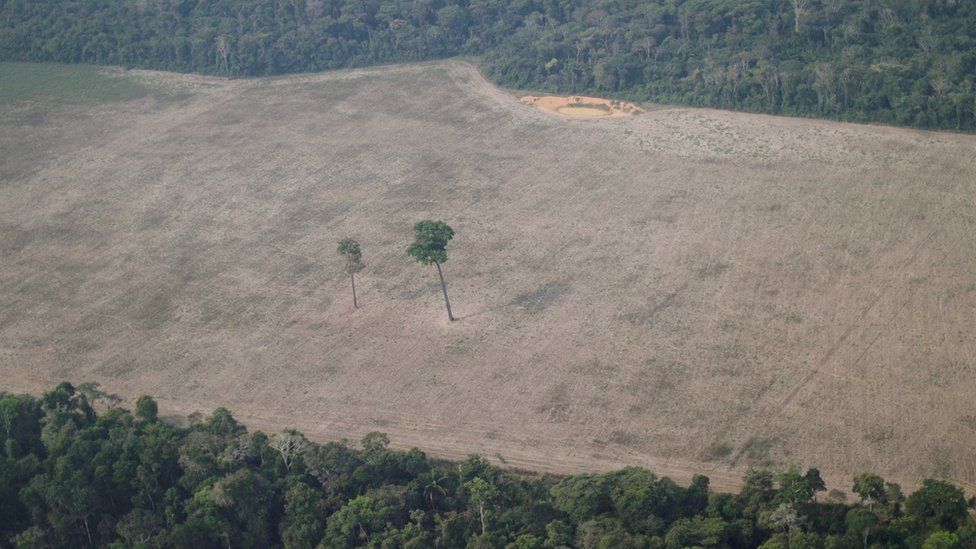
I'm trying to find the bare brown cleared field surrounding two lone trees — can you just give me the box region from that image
[0,61,976,489]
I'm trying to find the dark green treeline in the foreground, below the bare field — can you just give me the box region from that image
[0,383,976,549]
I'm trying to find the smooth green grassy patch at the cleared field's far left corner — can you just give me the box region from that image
[0,62,150,104]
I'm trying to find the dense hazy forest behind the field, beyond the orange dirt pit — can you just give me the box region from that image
[0,0,976,131]
